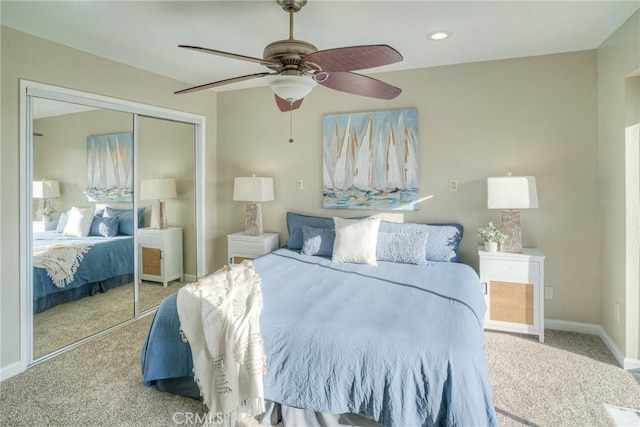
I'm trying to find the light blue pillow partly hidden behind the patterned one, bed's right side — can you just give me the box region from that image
[380,221,463,262]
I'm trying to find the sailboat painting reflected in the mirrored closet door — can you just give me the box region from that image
[86,132,133,203]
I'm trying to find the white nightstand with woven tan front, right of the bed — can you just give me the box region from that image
[478,246,544,342]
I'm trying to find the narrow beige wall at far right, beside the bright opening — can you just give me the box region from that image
[598,12,640,359]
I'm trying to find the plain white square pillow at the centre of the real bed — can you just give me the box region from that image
[331,217,380,265]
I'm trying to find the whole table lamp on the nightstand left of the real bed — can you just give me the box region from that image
[233,176,273,236]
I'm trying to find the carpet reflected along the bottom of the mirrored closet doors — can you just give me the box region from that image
[33,280,187,359]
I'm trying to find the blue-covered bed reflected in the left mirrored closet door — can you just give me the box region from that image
[33,206,135,313]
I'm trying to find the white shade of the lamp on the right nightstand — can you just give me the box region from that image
[487,176,538,209]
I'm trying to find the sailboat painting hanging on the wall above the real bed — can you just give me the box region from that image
[322,108,420,210]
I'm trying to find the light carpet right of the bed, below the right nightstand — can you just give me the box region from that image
[485,330,640,427]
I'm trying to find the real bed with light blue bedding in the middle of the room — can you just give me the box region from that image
[141,217,497,427]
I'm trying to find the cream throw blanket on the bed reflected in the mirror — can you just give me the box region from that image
[33,243,92,288]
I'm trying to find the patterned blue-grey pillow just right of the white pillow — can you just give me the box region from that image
[376,231,429,265]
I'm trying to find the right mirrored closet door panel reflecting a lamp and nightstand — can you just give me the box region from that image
[137,116,196,311]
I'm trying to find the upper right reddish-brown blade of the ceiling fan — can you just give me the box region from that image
[304,44,403,72]
